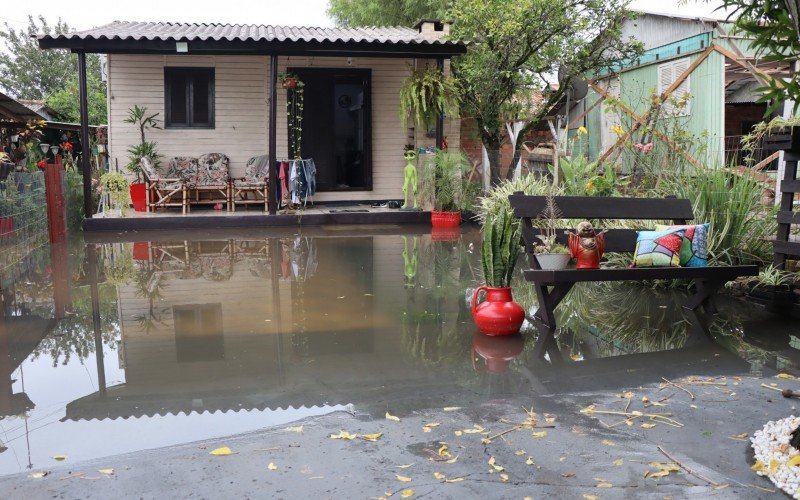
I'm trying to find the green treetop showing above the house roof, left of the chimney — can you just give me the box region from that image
[328,0,448,26]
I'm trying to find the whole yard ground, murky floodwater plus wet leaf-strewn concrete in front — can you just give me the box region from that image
[0,226,800,498]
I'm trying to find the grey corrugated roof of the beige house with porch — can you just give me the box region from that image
[39,21,462,45]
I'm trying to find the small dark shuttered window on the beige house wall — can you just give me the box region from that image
[164,68,214,128]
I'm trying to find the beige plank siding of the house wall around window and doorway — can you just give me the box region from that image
[108,54,461,201]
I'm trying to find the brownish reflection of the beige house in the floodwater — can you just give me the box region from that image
[65,233,470,420]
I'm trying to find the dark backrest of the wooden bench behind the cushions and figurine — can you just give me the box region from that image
[508,193,694,267]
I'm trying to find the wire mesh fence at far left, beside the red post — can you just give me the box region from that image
[0,172,48,280]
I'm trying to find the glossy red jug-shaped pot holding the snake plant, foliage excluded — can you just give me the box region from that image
[472,286,525,335]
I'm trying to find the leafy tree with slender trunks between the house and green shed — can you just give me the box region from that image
[450,0,640,184]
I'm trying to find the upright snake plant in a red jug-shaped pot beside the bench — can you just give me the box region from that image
[472,205,525,335]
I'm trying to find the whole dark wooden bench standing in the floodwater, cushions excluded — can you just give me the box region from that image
[509,193,758,341]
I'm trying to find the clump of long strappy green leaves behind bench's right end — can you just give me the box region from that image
[661,167,777,265]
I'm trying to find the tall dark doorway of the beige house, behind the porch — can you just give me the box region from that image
[289,68,372,191]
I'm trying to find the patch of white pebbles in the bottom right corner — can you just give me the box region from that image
[750,415,800,499]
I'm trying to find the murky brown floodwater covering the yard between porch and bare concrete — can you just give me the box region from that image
[0,226,800,474]
